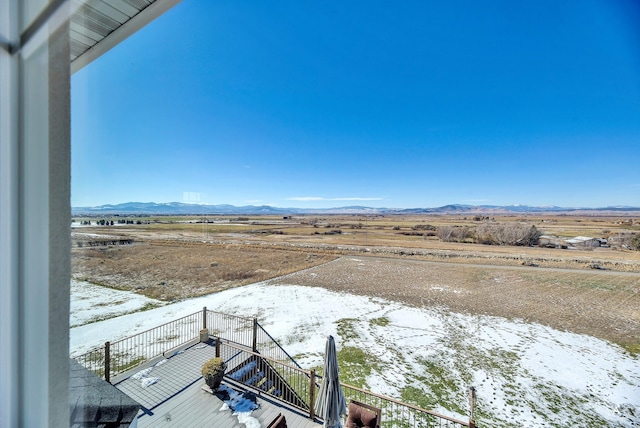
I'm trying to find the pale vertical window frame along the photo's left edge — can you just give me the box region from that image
[0,0,70,427]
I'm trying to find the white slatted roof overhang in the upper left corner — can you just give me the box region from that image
[69,0,181,73]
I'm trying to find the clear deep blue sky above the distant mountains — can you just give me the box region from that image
[71,0,640,208]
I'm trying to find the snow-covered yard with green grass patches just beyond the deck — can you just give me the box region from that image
[71,282,640,427]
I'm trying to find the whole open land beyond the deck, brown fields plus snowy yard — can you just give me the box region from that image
[72,216,640,427]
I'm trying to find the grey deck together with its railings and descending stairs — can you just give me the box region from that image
[73,307,475,428]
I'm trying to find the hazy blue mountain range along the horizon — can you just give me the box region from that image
[71,202,640,216]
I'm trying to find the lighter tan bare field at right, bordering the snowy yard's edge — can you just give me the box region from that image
[271,256,640,352]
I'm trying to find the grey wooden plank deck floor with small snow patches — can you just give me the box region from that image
[114,343,321,428]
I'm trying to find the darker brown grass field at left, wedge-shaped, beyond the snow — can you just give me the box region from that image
[72,241,333,300]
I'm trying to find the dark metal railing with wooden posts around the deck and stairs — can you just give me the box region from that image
[74,307,474,428]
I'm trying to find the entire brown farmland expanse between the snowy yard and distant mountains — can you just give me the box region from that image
[72,216,640,352]
